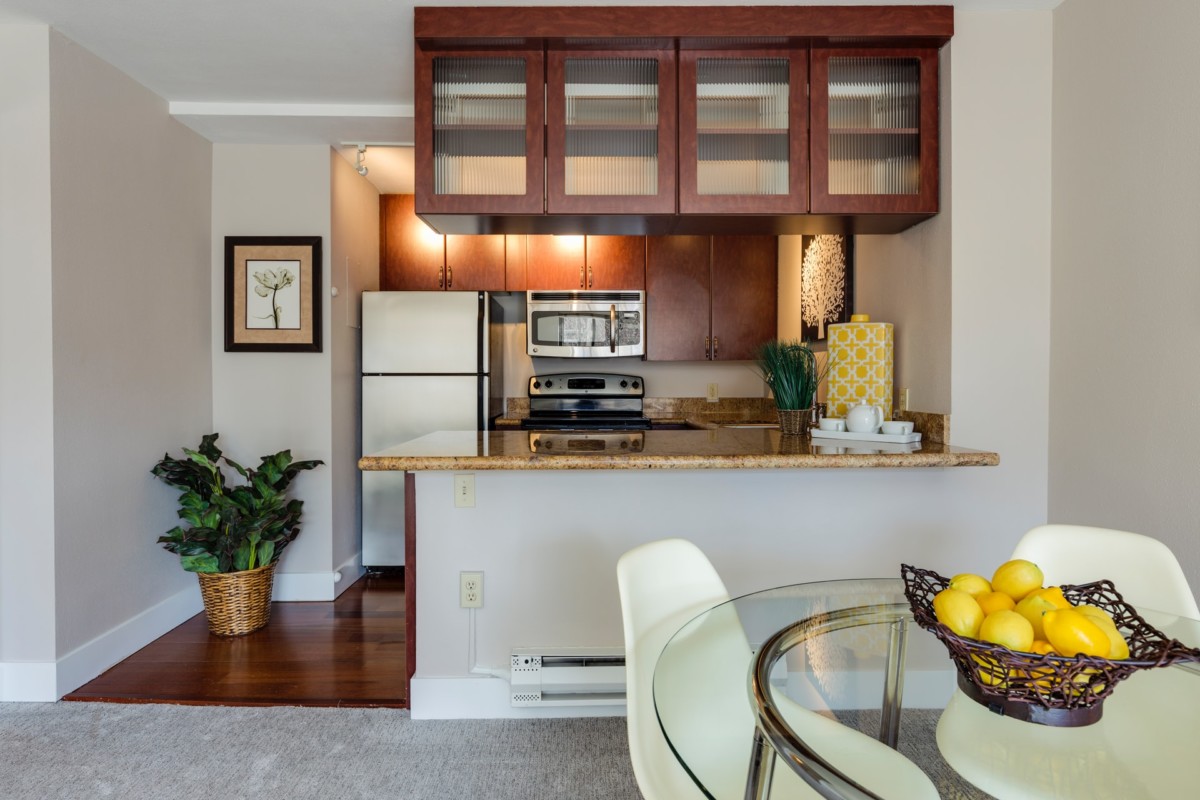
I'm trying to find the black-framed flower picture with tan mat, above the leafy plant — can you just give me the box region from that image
[224,236,322,353]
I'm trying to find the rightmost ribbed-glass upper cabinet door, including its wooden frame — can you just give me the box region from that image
[811,48,938,213]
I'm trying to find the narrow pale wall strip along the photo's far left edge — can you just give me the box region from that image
[0,25,55,699]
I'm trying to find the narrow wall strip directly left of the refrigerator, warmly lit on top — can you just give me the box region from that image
[329,151,379,575]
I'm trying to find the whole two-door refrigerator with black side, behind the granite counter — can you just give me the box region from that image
[362,291,504,567]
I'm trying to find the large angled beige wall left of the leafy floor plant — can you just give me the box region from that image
[50,34,212,654]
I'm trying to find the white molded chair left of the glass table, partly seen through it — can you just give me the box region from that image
[617,539,938,800]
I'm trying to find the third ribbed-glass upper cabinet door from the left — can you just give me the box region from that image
[679,49,809,213]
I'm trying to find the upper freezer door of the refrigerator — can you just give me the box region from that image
[362,291,490,374]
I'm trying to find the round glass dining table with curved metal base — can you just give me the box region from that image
[653,578,1200,800]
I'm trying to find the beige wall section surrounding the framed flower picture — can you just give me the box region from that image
[211,144,335,600]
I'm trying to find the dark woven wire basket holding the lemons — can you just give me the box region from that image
[900,564,1200,727]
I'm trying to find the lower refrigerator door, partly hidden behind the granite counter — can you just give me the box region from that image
[362,375,488,566]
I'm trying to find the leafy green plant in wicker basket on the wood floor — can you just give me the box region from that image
[150,433,323,636]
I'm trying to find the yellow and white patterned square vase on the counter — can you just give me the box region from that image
[826,314,894,420]
